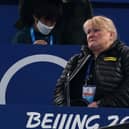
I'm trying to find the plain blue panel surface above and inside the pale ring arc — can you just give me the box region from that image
[0,45,80,105]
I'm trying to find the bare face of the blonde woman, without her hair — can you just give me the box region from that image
[85,24,112,53]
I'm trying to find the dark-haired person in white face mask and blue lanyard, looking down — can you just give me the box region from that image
[13,0,62,45]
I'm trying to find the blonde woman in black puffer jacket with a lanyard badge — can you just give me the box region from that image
[54,16,129,107]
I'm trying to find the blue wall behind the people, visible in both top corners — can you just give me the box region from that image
[0,0,129,44]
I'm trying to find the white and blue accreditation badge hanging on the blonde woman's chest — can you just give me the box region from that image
[82,84,96,103]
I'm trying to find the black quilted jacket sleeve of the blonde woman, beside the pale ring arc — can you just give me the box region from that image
[54,55,79,106]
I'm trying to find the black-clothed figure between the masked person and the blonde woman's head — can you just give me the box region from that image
[55,0,93,45]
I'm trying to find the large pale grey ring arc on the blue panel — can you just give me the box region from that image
[0,54,67,104]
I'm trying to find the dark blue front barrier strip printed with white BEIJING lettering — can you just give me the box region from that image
[0,105,129,129]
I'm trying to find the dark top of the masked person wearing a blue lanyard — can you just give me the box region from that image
[13,27,57,44]
